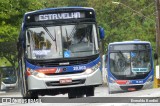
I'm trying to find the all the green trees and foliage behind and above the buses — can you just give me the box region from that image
[0,0,156,66]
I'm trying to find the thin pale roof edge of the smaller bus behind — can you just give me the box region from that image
[109,40,150,45]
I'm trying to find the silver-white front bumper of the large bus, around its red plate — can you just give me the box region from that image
[27,69,102,90]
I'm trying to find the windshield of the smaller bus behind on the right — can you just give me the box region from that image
[109,44,151,80]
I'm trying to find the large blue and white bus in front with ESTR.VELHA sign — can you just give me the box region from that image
[17,7,104,98]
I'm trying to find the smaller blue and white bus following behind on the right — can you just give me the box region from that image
[107,40,154,93]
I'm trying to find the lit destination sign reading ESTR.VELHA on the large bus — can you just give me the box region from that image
[35,12,85,21]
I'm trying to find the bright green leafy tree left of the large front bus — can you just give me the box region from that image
[0,0,45,66]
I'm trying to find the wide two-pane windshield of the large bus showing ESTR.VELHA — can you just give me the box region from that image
[26,24,98,59]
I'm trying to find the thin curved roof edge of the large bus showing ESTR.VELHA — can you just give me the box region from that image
[25,6,94,15]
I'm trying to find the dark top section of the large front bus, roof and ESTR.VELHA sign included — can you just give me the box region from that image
[23,7,96,25]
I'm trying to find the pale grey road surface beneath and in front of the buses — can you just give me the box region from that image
[0,86,160,106]
